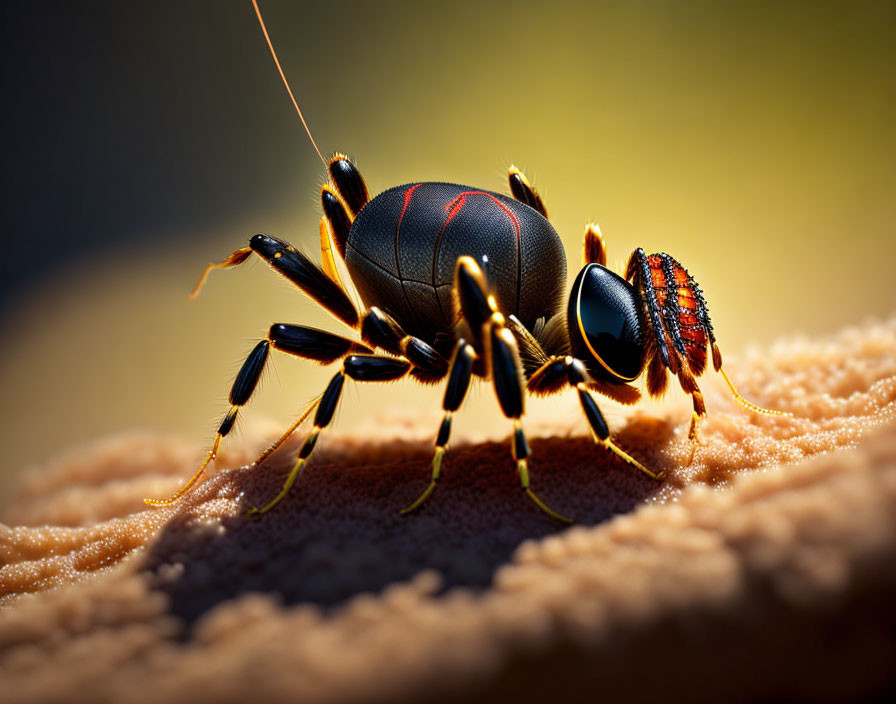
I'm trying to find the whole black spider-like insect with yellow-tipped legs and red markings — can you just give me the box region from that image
[146,1,780,521]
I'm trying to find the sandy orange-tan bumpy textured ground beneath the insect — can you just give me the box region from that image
[0,318,896,703]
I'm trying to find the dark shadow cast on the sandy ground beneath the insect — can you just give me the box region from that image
[146,427,672,624]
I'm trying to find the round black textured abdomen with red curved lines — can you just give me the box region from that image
[345,183,566,342]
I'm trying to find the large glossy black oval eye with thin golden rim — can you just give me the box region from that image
[567,264,644,381]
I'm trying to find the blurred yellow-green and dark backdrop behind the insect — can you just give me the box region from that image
[0,0,896,503]
